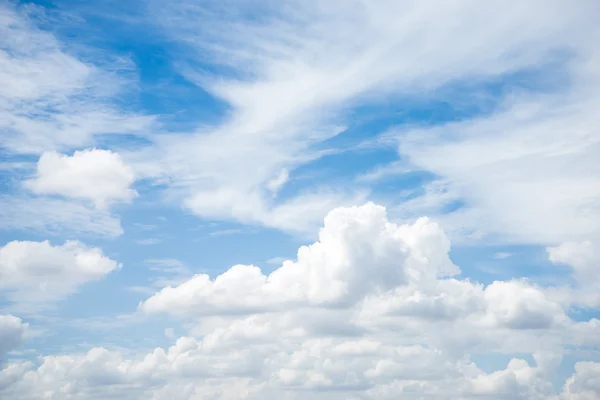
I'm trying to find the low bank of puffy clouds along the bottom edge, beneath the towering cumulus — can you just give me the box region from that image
[0,337,600,400]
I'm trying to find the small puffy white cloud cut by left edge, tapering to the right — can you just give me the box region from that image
[0,241,121,306]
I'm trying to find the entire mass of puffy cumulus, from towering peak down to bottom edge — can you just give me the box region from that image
[0,203,600,400]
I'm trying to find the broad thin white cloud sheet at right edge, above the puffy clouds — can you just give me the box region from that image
[384,3,600,245]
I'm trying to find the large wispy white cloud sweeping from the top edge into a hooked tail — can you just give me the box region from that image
[124,0,594,232]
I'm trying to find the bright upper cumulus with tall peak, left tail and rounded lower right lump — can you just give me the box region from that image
[140,203,566,329]
